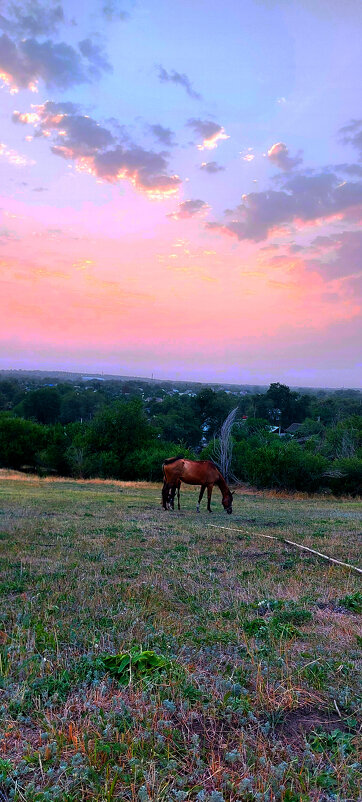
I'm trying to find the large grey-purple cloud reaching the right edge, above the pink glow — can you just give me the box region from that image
[206,172,362,242]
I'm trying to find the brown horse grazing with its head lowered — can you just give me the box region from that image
[162,457,233,515]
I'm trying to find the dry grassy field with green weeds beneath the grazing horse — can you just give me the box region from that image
[0,471,362,802]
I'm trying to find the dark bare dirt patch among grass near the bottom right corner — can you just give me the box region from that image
[275,707,348,742]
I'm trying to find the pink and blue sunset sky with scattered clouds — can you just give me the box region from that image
[0,0,362,387]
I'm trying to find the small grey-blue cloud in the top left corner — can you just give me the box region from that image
[0,0,64,36]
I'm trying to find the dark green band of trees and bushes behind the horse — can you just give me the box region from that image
[0,379,362,494]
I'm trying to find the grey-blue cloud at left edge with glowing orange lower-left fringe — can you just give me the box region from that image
[0,33,111,92]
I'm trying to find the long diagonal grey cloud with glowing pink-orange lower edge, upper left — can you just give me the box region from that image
[13,101,181,198]
